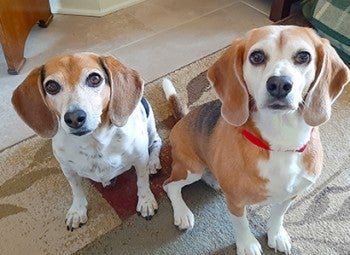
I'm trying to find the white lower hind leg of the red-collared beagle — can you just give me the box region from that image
[163,170,202,229]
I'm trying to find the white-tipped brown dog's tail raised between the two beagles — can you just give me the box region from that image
[163,78,188,121]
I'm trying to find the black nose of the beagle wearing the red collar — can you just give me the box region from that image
[266,76,293,98]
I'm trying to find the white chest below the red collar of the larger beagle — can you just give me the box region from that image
[258,152,316,203]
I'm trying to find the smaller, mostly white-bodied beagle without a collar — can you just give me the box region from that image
[12,52,161,231]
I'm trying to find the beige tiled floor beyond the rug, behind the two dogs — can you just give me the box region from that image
[0,0,272,151]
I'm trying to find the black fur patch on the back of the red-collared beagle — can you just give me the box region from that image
[195,100,221,136]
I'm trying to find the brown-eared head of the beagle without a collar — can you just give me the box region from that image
[12,53,143,138]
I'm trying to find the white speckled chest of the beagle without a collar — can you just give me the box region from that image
[53,125,142,184]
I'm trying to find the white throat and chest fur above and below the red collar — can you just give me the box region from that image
[253,110,317,203]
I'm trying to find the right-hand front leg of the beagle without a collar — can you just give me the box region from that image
[135,155,158,220]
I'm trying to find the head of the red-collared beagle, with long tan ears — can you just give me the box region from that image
[208,26,350,126]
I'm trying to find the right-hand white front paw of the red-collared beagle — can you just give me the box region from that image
[267,227,292,255]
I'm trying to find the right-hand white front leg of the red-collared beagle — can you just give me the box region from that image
[267,199,293,255]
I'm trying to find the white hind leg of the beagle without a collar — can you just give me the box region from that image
[147,108,162,174]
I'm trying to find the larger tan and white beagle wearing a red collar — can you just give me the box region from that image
[163,26,350,255]
